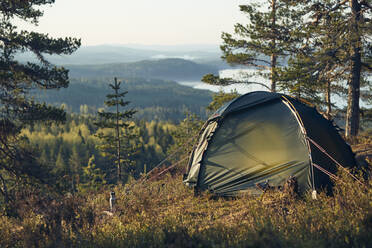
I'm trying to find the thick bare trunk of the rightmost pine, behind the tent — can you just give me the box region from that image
[345,0,362,138]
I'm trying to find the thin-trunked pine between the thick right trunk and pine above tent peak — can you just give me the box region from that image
[278,1,345,119]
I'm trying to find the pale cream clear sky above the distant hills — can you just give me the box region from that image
[17,0,248,46]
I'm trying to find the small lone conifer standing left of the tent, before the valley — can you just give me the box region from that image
[96,78,138,183]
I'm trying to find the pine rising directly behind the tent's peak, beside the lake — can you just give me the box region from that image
[202,0,302,92]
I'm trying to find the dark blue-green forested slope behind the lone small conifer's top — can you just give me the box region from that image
[34,77,212,121]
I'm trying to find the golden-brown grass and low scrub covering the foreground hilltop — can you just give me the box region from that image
[0,142,372,248]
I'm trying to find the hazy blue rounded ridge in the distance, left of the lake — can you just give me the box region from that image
[66,59,218,81]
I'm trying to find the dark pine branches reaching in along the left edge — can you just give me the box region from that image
[0,0,80,200]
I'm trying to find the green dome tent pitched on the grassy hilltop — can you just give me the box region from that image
[184,91,355,196]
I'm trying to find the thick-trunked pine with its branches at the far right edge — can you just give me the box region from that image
[311,0,372,137]
